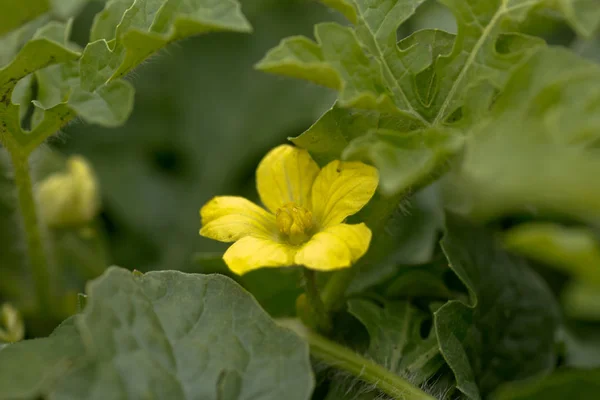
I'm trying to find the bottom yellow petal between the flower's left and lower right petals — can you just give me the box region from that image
[223,236,296,275]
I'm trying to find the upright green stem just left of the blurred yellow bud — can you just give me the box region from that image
[8,149,52,311]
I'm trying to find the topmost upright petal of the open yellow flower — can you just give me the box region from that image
[256,145,319,213]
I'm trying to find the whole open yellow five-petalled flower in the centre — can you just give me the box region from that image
[200,145,379,275]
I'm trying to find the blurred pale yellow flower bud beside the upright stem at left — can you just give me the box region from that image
[38,156,100,227]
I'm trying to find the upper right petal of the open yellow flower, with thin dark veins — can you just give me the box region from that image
[312,161,379,228]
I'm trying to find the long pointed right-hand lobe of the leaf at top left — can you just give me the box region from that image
[81,0,252,91]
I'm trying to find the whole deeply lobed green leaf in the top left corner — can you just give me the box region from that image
[0,0,251,152]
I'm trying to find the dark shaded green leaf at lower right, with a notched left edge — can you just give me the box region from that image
[434,215,559,399]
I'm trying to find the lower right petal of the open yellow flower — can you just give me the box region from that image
[295,224,371,271]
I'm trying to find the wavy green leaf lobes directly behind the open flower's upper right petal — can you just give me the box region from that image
[292,105,463,195]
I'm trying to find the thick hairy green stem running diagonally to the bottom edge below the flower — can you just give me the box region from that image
[277,319,435,400]
